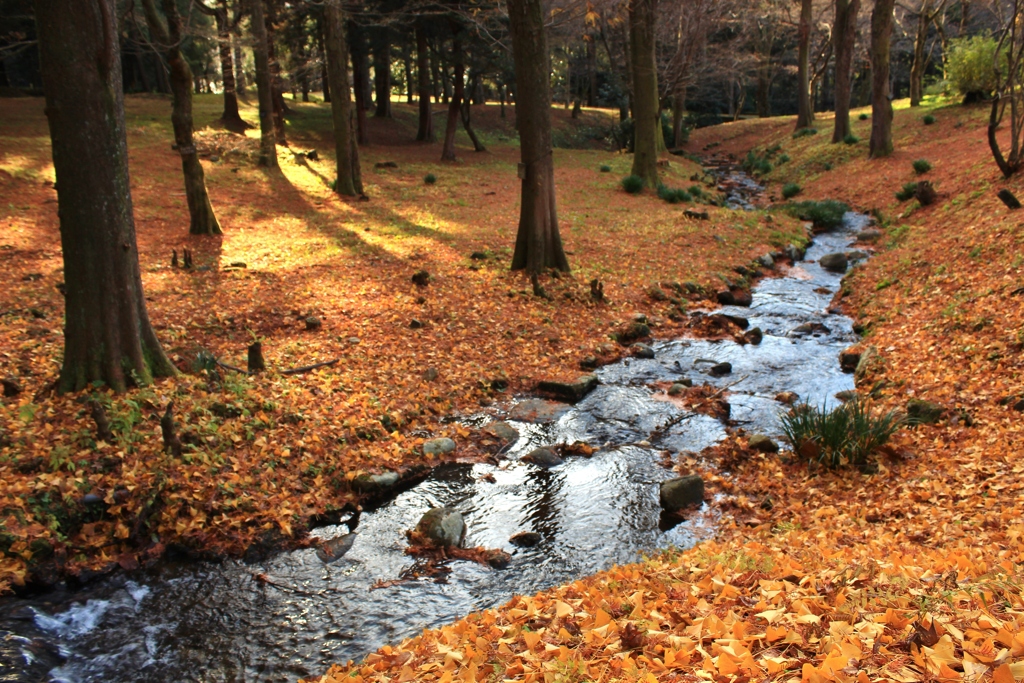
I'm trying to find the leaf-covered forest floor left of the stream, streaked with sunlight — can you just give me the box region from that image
[0,95,804,593]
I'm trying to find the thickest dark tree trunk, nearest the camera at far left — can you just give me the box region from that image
[35,0,175,392]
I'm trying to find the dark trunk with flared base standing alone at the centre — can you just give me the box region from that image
[508,0,569,275]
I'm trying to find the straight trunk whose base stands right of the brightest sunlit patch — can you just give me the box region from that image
[324,0,362,197]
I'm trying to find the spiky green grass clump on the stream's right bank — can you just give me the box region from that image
[782,398,906,469]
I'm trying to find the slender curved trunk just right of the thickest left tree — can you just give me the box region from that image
[142,0,221,234]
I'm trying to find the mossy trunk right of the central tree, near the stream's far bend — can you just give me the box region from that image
[630,0,660,188]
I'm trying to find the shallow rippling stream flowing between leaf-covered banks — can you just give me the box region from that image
[0,178,867,683]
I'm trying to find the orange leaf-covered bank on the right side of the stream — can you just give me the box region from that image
[307,102,1024,683]
